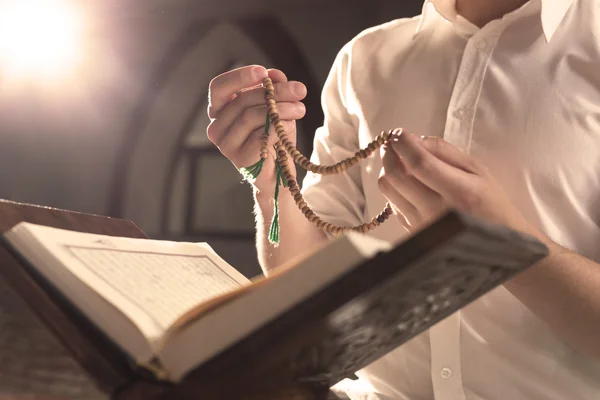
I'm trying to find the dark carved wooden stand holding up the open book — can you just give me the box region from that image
[0,201,547,400]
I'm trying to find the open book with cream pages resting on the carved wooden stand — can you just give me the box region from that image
[4,222,389,382]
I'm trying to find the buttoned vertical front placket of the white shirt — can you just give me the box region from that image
[430,21,503,400]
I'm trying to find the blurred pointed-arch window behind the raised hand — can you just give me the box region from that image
[111,18,322,276]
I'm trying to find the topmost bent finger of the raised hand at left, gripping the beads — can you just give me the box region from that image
[208,65,268,119]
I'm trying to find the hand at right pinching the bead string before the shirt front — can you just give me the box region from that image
[379,132,541,241]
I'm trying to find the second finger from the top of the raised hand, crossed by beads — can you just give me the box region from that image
[207,82,306,141]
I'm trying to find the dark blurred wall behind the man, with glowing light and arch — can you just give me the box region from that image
[0,0,422,277]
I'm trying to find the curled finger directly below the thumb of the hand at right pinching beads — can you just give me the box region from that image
[382,147,442,217]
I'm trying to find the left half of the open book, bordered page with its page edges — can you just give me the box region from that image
[5,222,250,350]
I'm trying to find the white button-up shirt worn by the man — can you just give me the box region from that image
[303,0,600,400]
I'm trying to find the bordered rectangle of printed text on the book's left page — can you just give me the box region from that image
[66,246,241,330]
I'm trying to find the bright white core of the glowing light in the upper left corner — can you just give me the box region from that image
[0,0,82,80]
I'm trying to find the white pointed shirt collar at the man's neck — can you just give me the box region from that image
[415,0,574,42]
